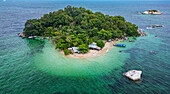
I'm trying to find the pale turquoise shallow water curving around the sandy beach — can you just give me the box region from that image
[34,41,128,77]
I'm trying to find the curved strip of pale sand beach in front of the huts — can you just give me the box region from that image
[60,41,118,58]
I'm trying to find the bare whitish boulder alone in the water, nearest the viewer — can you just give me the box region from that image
[124,70,142,81]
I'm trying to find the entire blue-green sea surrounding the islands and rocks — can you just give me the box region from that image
[0,0,170,94]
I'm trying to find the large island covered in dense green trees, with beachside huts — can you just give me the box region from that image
[20,6,141,57]
